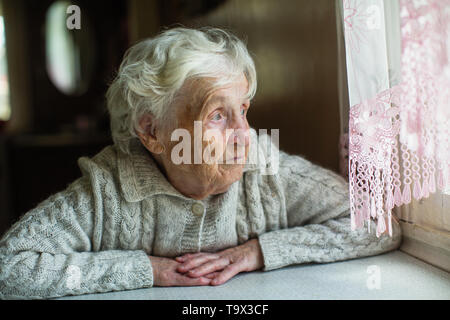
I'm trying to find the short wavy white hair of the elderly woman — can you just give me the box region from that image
[106,27,256,153]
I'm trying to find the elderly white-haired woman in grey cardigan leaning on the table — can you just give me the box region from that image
[0,28,401,298]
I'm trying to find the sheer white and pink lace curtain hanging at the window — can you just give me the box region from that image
[336,0,450,236]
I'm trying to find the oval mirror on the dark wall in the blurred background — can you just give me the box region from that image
[45,1,95,95]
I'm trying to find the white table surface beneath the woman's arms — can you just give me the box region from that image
[59,250,450,300]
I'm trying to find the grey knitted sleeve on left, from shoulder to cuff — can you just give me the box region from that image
[0,176,153,299]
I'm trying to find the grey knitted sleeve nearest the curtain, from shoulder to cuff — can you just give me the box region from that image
[259,151,401,271]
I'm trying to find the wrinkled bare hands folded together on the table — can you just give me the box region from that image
[149,239,264,287]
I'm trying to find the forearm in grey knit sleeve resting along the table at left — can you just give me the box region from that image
[0,247,153,299]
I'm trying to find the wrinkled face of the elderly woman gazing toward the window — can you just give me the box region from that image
[153,75,250,199]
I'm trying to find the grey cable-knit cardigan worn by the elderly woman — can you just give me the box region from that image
[0,129,401,299]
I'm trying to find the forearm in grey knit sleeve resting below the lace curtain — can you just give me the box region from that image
[259,217,401,271]
